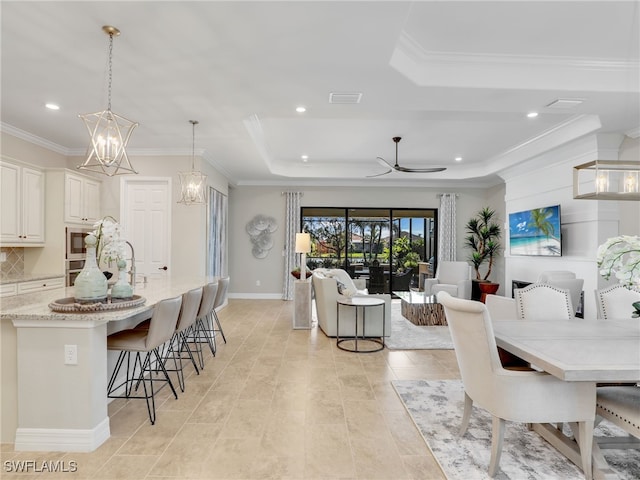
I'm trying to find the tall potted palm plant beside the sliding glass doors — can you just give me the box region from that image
[464,207,502,300]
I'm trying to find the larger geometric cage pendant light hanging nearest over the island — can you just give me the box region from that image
[77,25,138,177]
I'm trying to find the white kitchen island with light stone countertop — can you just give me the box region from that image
[0,277,215,452]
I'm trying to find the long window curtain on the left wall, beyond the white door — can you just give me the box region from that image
[207,187,228,277]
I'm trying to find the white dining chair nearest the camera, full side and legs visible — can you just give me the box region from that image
[437,292,596,478]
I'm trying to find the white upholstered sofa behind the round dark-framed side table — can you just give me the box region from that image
[311,268,391,337]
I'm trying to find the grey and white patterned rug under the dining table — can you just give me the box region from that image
[392,380,640,480]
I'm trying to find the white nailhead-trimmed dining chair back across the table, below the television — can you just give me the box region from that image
[514,283,575,320]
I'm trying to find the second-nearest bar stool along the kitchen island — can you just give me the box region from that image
[164,287,203,392]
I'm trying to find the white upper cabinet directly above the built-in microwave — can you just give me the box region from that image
[64,172,100,225]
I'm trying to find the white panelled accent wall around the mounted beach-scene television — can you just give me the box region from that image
[503,135,640,318]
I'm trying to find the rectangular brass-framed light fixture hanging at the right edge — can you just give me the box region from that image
[573,160,640,201]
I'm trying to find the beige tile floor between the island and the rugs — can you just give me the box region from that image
[0,299,459,480]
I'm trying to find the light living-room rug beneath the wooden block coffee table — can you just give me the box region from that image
[385,300,453,350]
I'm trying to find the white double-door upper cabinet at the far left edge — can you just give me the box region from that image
[0,160,45,246]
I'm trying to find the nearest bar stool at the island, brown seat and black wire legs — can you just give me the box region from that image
[107,296,182,425]
